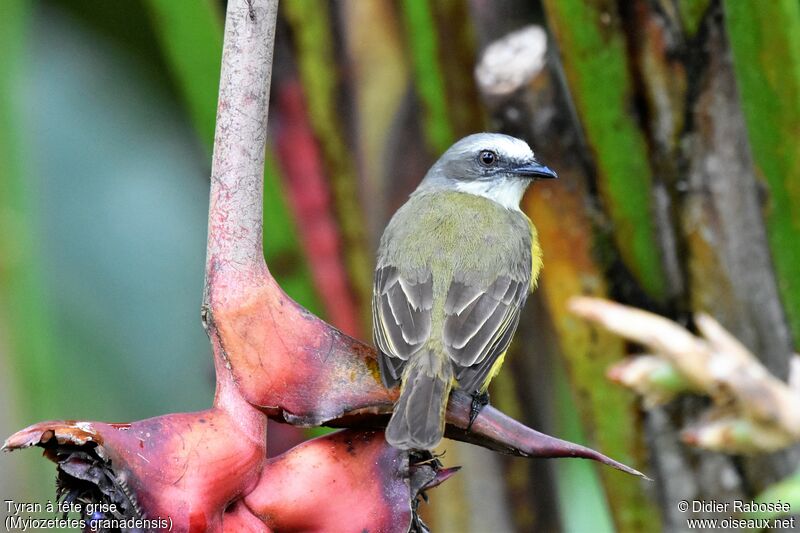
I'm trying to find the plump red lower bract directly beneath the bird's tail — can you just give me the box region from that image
[244,430,446,532]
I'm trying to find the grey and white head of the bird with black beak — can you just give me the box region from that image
[420,133,557,209]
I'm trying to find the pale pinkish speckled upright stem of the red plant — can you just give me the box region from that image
[203,0,278,439]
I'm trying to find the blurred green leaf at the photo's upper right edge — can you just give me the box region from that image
[724,0,800,346]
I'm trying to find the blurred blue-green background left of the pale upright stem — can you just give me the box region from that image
[0,0,213,512]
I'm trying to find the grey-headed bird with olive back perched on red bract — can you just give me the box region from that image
[372,133,557,450]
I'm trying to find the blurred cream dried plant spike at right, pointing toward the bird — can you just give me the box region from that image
[570,297,800,453]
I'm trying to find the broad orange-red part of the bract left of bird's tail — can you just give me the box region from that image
[209,268,397,425]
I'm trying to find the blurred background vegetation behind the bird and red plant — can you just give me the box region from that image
[0,0,800,531]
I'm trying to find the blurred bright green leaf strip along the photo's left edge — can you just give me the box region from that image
[0,0,58,418]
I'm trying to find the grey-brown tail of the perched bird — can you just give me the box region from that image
[386,362,452,450]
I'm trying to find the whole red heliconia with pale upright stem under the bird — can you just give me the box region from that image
[4,0,641,532]
